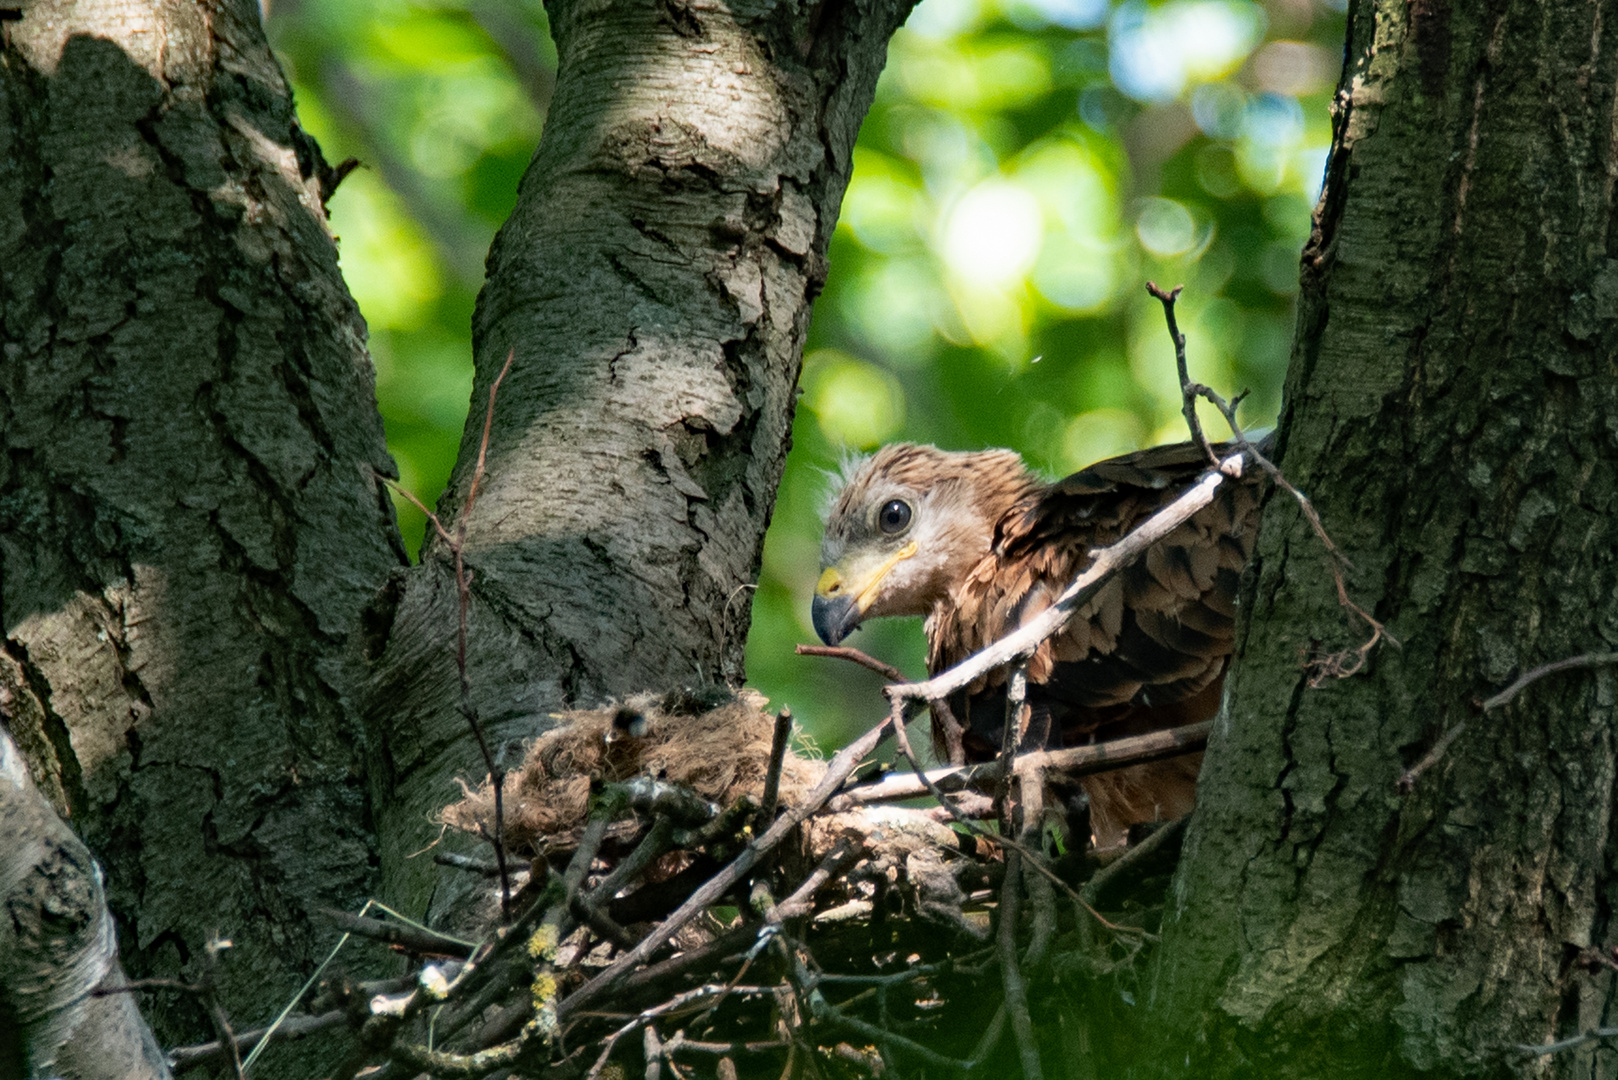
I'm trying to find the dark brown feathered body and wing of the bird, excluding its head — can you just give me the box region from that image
[927,444,1260,844]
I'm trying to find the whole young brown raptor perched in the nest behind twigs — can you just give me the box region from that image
[814,444,1260,845]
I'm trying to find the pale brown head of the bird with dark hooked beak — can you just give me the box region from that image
[812,442,1039,644]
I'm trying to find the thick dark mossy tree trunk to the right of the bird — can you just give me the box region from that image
[1141,0,1618,1077]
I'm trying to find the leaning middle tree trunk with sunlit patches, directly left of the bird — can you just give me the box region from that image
[367,0,909,910]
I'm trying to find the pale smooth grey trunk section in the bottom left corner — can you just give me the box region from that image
[0,729,168,1080]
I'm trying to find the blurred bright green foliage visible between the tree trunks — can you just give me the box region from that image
[269,0,1345,746]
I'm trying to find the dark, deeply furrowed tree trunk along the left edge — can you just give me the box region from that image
[0,0,401,1062]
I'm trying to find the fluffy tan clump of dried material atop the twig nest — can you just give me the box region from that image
[440,690,825,850]
